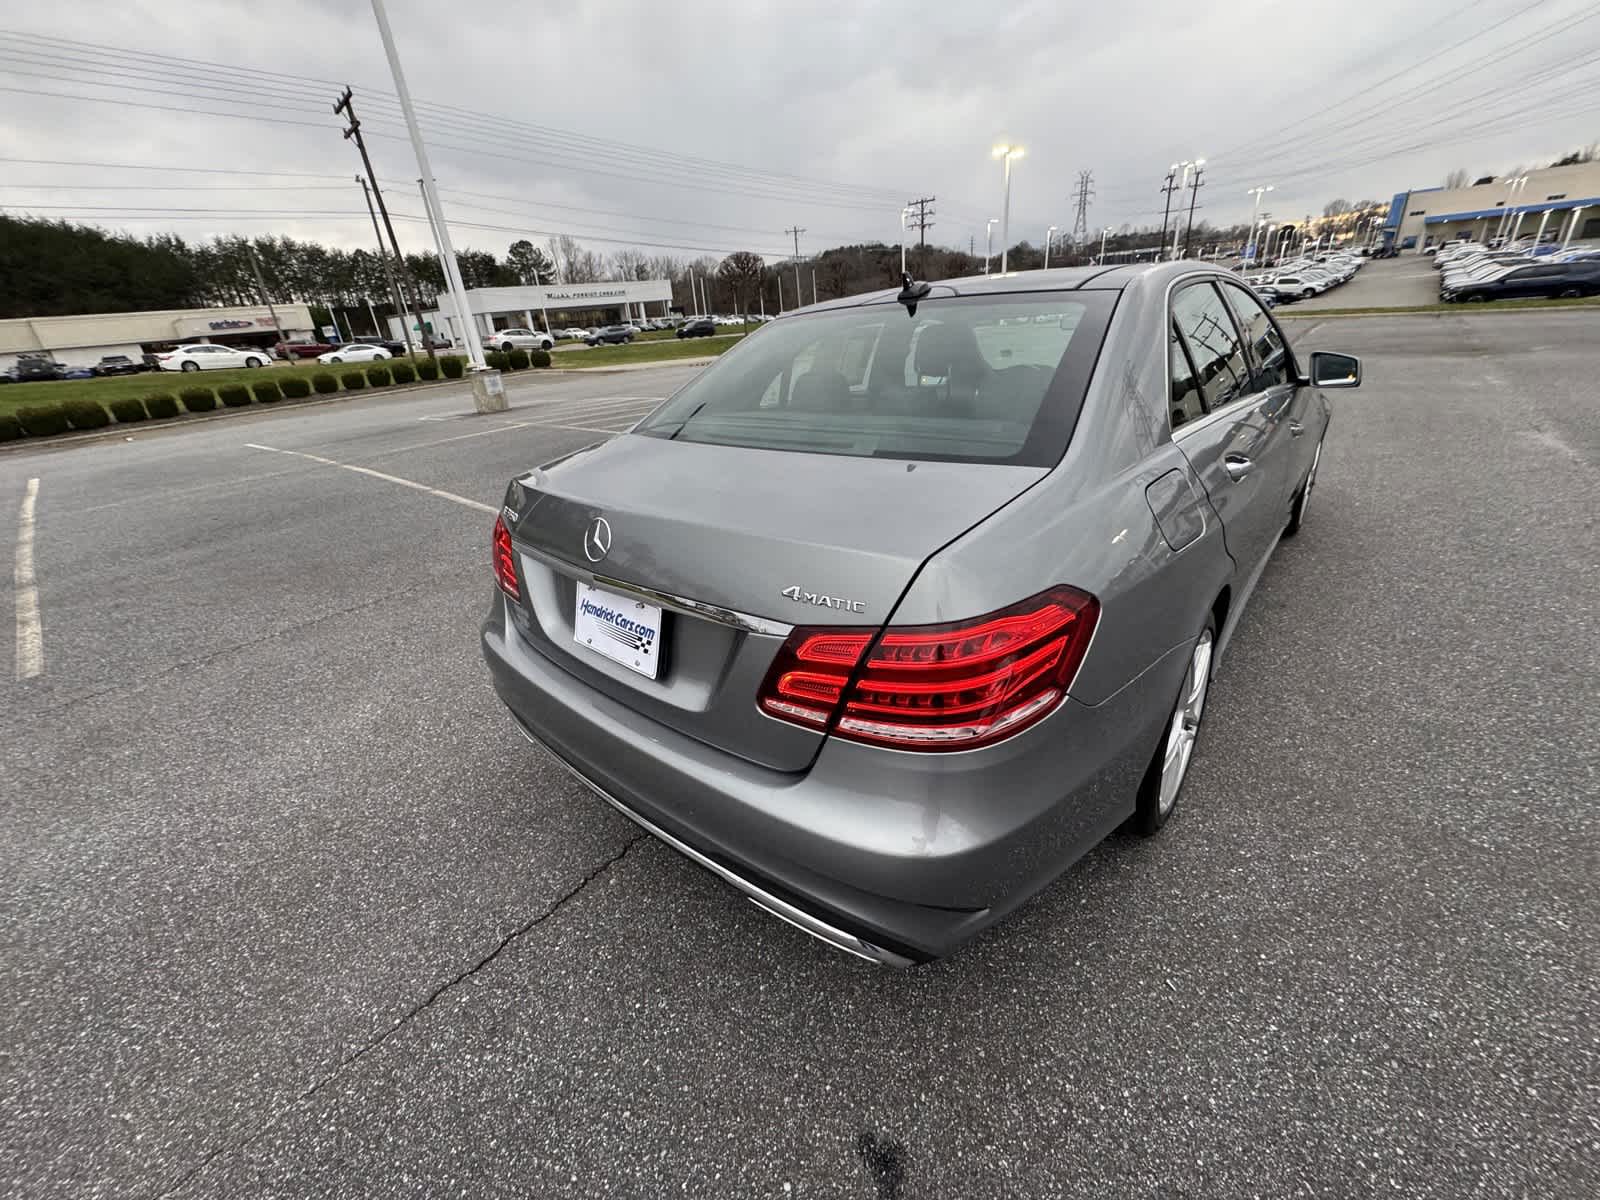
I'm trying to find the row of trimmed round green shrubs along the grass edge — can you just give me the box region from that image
[0,360,473,442]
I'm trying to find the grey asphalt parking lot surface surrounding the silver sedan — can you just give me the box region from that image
[0,320,1600,1200]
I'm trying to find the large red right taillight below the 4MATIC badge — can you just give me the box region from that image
[757,586,1099,750]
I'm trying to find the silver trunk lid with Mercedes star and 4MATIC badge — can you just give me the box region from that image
[504,435,1046,771]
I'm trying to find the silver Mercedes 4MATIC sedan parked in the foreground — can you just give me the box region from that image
[483,264,1360,965]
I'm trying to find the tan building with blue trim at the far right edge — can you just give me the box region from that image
[1382,162,1600,251]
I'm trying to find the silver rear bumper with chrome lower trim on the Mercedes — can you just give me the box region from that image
[483,597,1187,965]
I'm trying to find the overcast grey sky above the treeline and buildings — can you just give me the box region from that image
[0,0,1600,265]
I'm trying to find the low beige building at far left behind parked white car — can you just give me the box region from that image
[0,304,315,371]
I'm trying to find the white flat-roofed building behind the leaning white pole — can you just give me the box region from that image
[389,278,672,342]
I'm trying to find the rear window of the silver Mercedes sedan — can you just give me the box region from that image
[637,291,1115,466]
